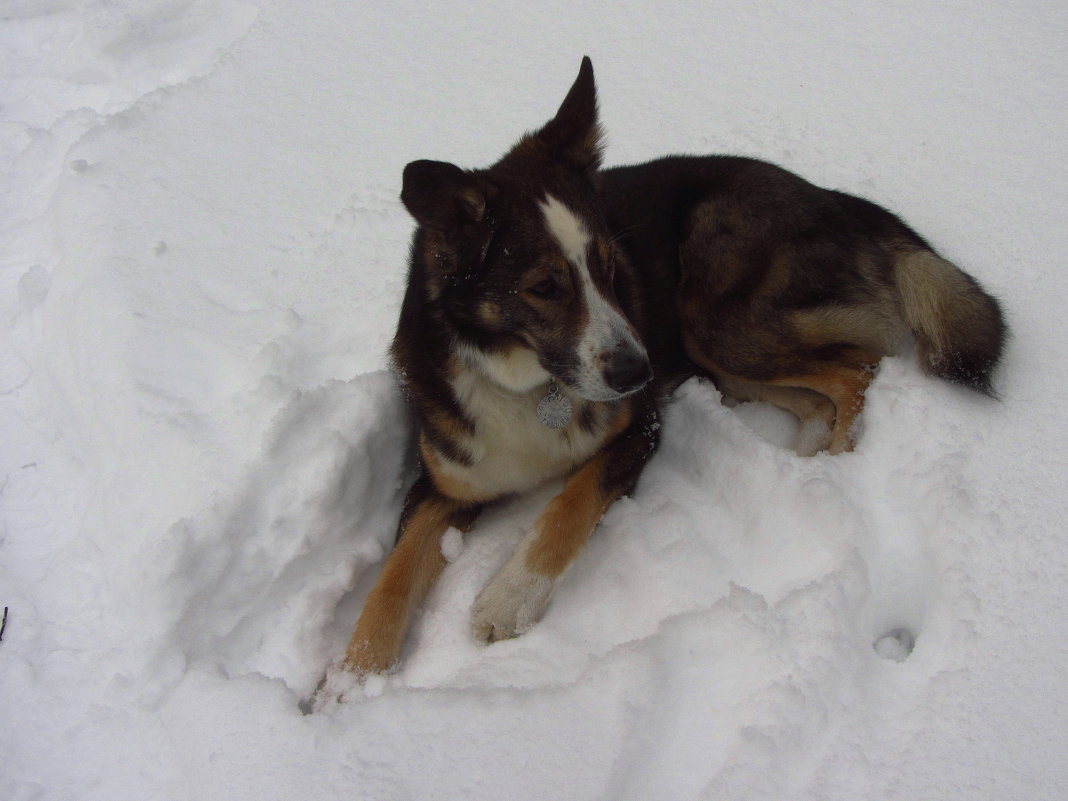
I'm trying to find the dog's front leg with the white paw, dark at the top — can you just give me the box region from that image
[472,409,658,643]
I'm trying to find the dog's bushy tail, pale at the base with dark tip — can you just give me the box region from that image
[894,248,1008,396]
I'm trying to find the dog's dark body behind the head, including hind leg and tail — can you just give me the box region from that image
[603,156,1006,453]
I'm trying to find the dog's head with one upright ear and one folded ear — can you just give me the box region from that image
[401,58,650,401]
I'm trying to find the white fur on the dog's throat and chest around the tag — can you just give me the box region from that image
[429,347,604,500]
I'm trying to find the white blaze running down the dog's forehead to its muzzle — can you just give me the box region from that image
[538,194,645,401]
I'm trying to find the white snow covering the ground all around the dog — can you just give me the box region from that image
[0,0,1068,801]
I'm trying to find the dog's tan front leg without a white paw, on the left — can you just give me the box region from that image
[342,474,478,676]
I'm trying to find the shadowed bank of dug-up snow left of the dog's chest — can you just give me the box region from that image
[159,373,409,692]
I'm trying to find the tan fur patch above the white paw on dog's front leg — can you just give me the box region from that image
[527,452,610,579]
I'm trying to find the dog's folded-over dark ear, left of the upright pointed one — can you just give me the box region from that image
[401,160,487,233]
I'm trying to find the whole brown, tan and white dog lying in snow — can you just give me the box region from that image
[322,58,1007,677]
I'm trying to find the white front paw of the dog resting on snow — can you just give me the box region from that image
[471,554,553,643]
